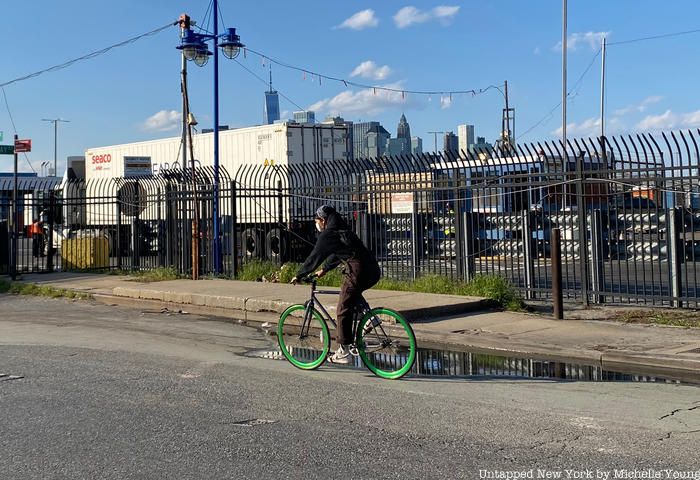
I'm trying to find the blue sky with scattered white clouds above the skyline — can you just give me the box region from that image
[0,0,700,171]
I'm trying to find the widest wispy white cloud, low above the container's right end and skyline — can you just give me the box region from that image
[308,83,411,117]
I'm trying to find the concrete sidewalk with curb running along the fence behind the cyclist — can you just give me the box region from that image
[9,273,700,384]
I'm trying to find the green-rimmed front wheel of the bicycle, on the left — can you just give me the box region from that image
[277,305,331,370]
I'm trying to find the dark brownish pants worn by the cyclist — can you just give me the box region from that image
[336,258,382,345]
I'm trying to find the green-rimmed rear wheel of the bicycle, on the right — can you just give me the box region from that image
[355,308,417,380]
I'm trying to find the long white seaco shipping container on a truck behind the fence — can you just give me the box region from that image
[80,122,351,225]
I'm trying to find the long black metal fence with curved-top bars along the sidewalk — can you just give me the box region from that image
[0,131,700,306]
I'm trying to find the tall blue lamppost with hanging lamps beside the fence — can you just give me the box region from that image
[177,5,244,273]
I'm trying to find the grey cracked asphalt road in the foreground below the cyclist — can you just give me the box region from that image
[0,295,700,479]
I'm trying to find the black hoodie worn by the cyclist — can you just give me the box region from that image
[297,212,377,278]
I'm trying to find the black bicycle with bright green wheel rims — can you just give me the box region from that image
[277,276,417,380]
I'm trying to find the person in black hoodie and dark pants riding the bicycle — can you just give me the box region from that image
[291,205,382,365]
